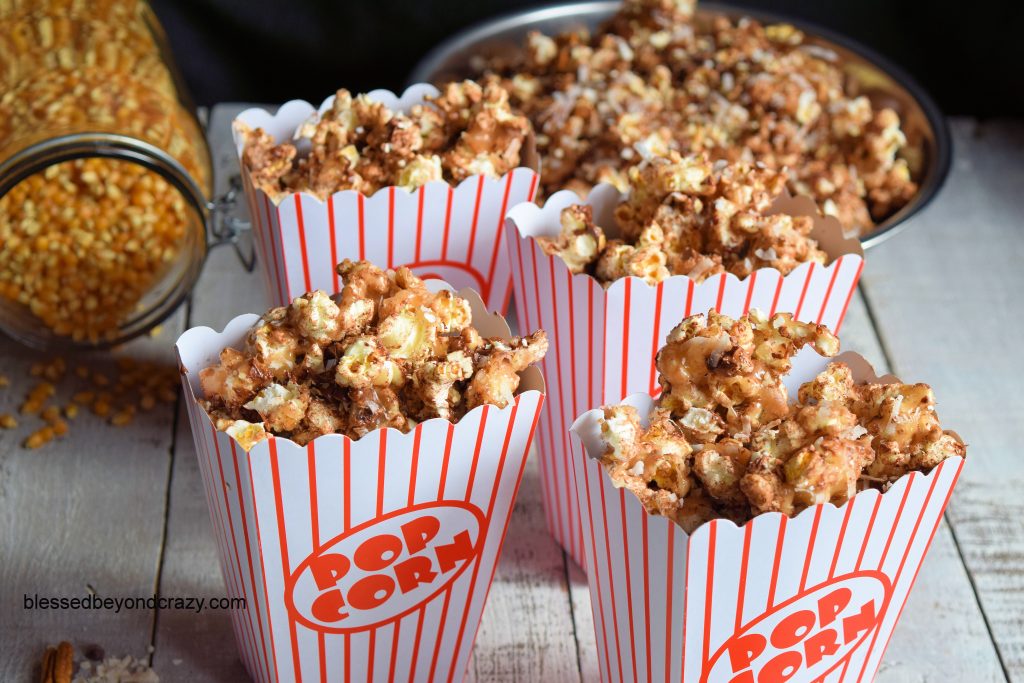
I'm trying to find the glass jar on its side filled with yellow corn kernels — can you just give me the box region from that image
[0,0,234,348]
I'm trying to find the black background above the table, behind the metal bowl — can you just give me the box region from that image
[152,0,1024,117]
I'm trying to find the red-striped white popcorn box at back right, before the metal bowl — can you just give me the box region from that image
[505,184,863,568]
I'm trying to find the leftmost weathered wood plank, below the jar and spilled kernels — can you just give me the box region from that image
[0,311,184,681]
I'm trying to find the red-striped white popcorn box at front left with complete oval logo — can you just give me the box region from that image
[177,292,544,683]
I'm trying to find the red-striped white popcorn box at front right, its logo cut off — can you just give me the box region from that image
[571,348,964,683]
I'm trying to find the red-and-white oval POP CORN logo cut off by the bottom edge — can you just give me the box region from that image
[700,571,891,683]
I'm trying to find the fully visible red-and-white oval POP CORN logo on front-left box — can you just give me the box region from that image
[285,501,484,633]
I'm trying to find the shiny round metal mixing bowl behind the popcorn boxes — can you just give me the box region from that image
[410,2,952,248]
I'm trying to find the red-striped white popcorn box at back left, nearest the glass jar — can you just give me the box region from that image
[232,83,539,313]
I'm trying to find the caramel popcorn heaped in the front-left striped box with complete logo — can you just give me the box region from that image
[200,260,548,450]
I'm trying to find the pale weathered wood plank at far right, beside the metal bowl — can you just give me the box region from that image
[863,121,1024,680]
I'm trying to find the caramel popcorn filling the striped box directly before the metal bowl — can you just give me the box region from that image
[538,152,827,285]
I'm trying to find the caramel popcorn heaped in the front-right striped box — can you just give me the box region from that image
[601,311,967,531]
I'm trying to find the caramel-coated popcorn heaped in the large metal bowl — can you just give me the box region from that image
[483,0,916,234]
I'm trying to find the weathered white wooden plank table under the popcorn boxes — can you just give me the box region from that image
[0,104,1024,683]
